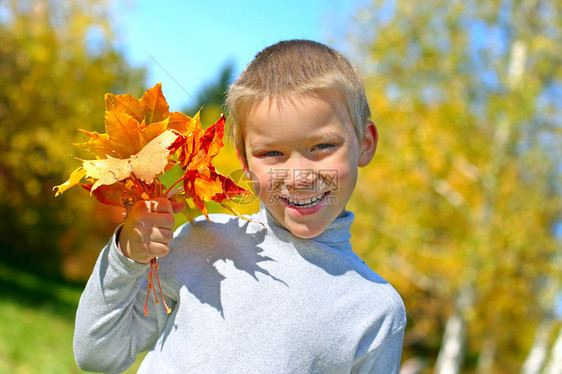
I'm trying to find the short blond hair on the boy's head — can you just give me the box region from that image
[226,40,371,163]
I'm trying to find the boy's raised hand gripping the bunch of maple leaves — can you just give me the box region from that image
[119,198,182,264]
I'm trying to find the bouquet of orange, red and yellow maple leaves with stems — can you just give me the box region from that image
[55,83,247,315]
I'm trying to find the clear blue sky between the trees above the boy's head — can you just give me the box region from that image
[113,0,361,110]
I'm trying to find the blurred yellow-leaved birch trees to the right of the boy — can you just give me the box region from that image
[348,0,562,373]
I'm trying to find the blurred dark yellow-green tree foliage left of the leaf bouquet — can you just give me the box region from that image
[0,0,144,277]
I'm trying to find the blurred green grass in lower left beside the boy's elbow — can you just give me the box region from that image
[0,263,141,374]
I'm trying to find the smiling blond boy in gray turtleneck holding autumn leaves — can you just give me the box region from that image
[74,40,406,374]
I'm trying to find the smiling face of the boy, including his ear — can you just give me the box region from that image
[244,97,377,239]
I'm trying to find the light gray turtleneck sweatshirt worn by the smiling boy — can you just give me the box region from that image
[74,208,406,374]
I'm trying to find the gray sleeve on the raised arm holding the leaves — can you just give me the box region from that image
[73,231,173,372]
